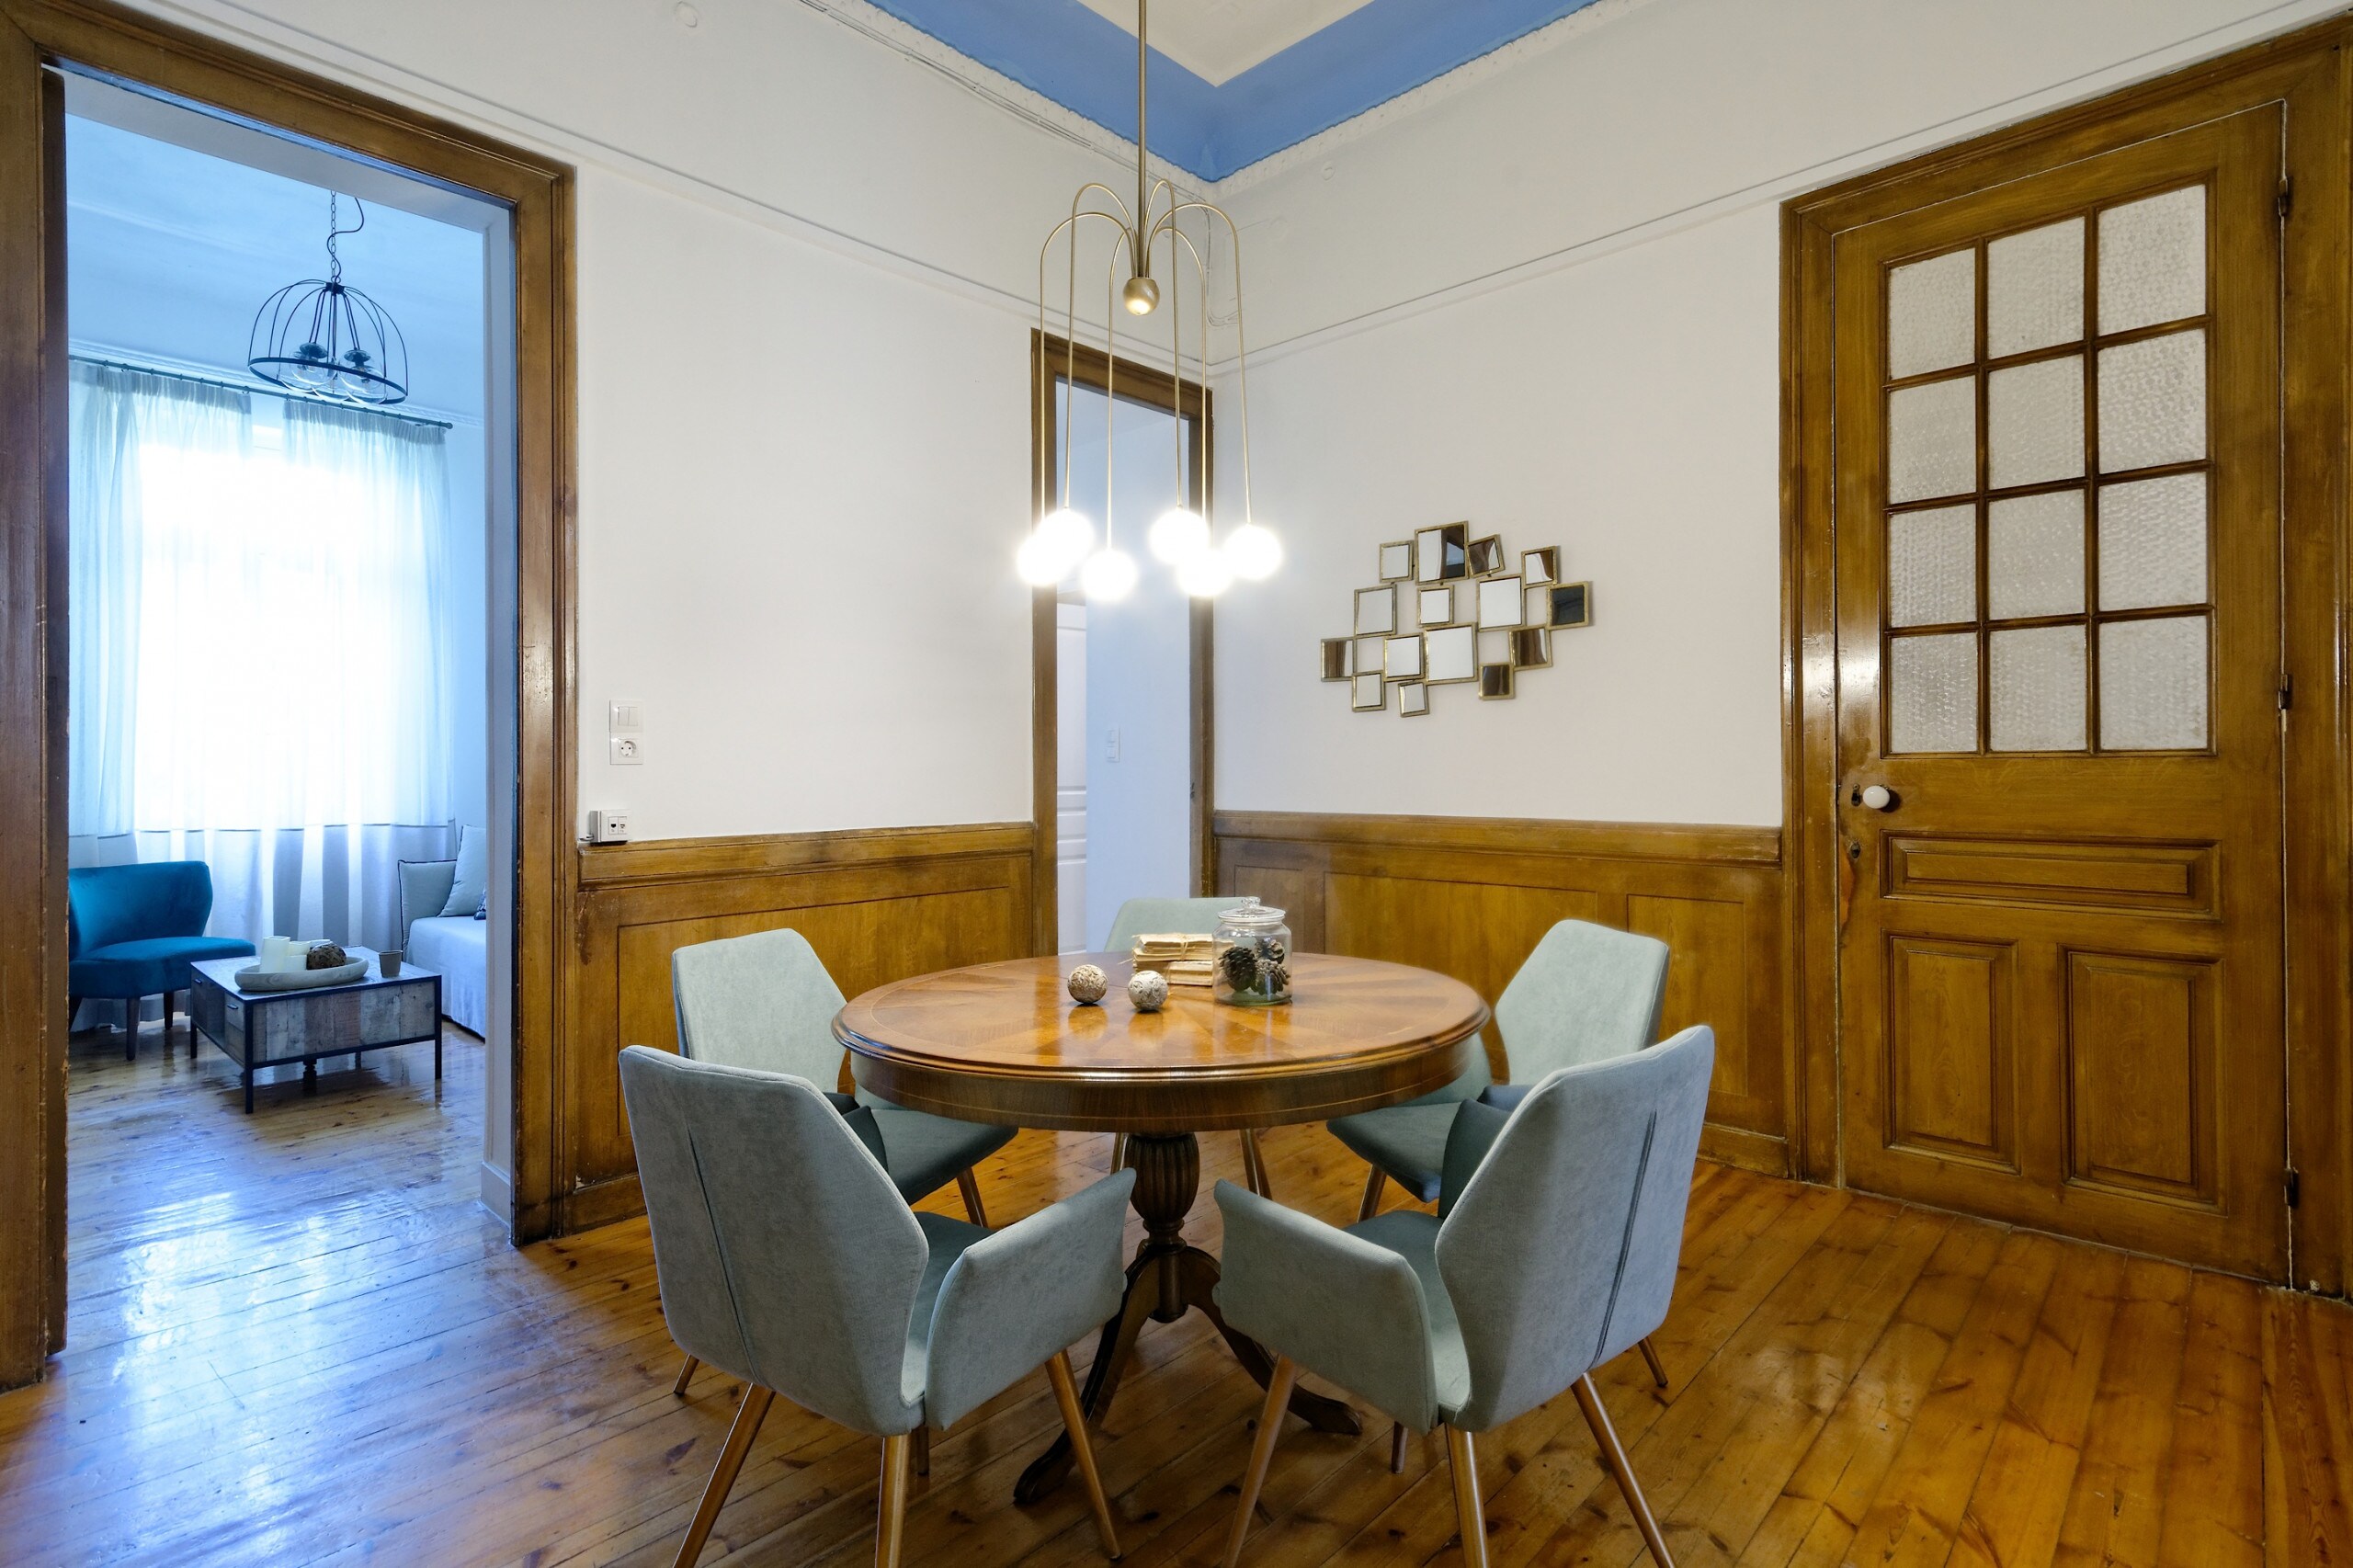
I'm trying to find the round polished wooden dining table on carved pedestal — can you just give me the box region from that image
[833,953,1487,1502]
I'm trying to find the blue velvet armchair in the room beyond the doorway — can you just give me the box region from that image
[66,859,254,1062]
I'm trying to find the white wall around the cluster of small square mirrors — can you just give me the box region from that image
[1217,0,2335,824]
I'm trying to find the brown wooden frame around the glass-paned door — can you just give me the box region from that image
[1781,18,2353,1292]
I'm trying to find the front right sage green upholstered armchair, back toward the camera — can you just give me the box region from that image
[1217,1024,1715,1568]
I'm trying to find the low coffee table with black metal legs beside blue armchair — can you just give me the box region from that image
[188,947,440,1116]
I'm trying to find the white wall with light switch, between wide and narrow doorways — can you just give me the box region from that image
[148,0,1139,838]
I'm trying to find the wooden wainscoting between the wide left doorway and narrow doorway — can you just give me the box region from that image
[564,822,1033,1229]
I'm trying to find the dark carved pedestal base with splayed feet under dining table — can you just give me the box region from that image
[1014,1132,1365,1502]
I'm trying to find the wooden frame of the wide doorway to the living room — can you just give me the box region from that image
[0,0,579,1387]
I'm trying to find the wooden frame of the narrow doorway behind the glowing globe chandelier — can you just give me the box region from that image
[1030,327,1217,953]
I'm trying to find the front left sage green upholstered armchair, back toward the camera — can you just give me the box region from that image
[621,1045,1136,1568]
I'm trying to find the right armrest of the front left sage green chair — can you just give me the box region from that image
[925,1170,1136,1426]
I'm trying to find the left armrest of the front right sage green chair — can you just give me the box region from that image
[1217,1182,1438,1431]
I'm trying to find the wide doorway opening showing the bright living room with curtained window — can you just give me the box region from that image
[62,73,517,1309]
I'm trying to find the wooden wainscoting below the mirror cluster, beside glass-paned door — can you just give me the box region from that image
[1217,812,1789,1173]
